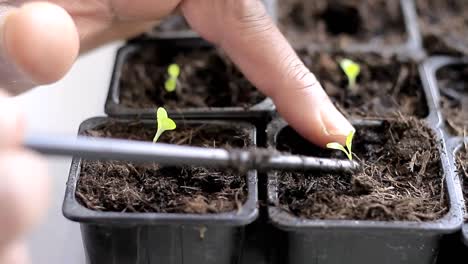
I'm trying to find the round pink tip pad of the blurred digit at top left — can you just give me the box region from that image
[3,2,79,84]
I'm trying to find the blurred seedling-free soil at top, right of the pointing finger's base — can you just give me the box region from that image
[278,0,407,46]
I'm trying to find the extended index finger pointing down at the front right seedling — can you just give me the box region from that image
[181,0,354,146]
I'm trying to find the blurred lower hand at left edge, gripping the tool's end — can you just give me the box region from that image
[0,91,49,264]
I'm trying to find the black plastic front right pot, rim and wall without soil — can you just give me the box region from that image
[268,119,463,264]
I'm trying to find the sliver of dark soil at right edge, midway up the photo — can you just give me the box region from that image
[437,65,468,136]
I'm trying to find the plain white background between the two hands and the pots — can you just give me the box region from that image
[14,43,119,264]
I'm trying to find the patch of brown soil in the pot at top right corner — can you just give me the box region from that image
[416,0,468,55]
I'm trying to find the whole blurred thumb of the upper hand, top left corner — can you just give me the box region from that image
[0,2,79,95]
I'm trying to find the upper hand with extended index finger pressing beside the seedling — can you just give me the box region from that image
[0,0,353,146]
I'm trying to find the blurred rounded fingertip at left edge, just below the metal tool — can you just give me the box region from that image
[0,150,49,245]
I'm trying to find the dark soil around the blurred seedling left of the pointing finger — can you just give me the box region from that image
[120,45,265,110]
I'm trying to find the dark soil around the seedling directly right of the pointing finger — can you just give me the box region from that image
[299,50,428,118]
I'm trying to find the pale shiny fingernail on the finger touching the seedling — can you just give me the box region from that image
[320,100,355,141]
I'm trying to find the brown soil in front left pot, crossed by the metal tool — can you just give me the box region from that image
[76,122,251,214]
